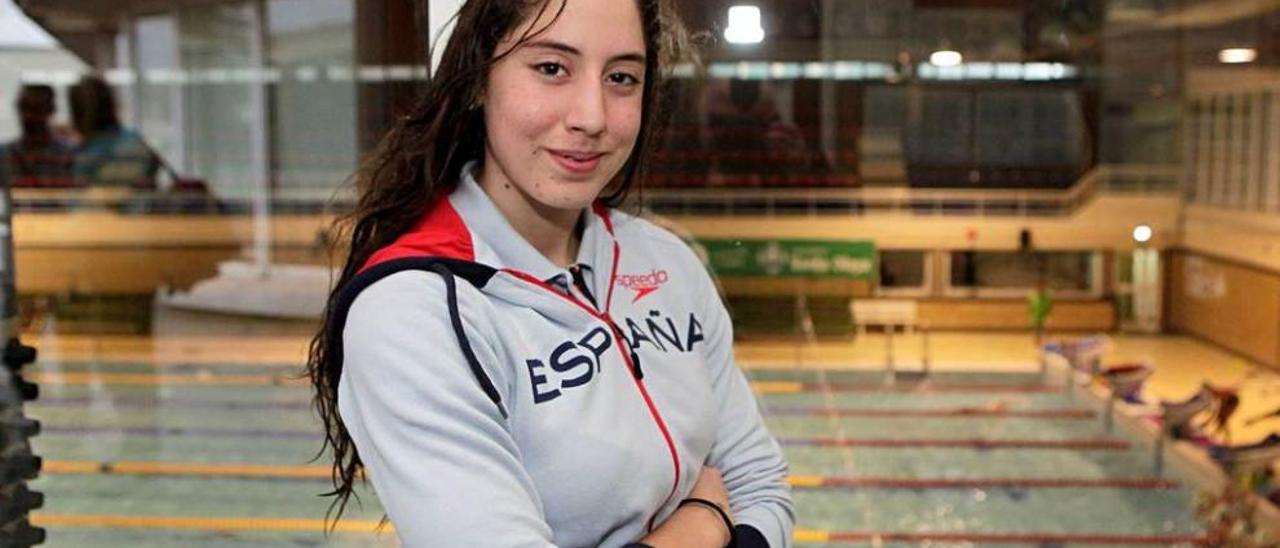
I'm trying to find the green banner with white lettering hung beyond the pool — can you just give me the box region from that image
[698,238,876,280]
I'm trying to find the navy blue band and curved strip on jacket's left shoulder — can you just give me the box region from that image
[325,257,507,419]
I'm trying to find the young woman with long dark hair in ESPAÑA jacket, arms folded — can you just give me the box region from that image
[308,0,794,547]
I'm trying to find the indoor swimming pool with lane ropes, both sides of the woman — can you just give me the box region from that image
[22,362,1202,547]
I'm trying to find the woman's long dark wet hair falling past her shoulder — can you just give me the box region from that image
[306,0,686,524]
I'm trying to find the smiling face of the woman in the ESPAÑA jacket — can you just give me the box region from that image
[481,0,646,215]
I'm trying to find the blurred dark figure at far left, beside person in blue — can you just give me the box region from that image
[0,85,74,188]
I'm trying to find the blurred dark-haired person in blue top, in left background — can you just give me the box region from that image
[69,76,160,191]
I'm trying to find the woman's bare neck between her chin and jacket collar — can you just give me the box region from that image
[475,161,582,266]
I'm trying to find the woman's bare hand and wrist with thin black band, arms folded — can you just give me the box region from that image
[640,466,732,548]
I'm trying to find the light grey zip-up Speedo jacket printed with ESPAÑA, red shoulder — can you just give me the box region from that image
[329,165,794,547]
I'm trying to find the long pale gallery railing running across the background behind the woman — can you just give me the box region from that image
[2,164,1181,216]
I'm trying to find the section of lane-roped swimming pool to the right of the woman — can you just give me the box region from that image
[750,371,1202,545]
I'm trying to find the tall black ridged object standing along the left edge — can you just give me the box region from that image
[0,169,45,548]
